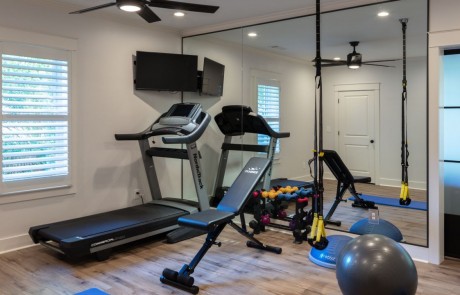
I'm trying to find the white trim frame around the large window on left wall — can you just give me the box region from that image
[0,27,77,204]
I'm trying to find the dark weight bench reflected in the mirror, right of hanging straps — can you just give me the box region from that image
[323,150,377,226]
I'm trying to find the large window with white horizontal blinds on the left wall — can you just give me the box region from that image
[0,43,70,194]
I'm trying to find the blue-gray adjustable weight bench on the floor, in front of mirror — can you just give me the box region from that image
[160,157,282,294]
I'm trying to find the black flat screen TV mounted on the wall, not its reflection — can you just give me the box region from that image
[134,51,198,92]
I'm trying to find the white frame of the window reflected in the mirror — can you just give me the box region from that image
[251,70,282,155]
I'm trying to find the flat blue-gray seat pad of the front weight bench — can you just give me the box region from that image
[177,209,235,231]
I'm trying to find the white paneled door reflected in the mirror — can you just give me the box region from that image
[336,86,378,183]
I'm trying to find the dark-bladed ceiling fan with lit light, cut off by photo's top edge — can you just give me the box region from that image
[70,0,219,23]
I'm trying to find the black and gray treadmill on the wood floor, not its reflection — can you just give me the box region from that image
[29,103,211,261]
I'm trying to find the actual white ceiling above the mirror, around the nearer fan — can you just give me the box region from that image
[42,0,383,35]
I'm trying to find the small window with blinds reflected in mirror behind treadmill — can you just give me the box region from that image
[255,77,280,153]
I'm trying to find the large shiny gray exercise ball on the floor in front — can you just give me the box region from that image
[336,234,418,295]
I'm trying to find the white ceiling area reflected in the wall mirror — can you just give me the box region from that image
[204,0,427,61]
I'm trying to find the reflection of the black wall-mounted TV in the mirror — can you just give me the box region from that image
[200,57,225,96]
